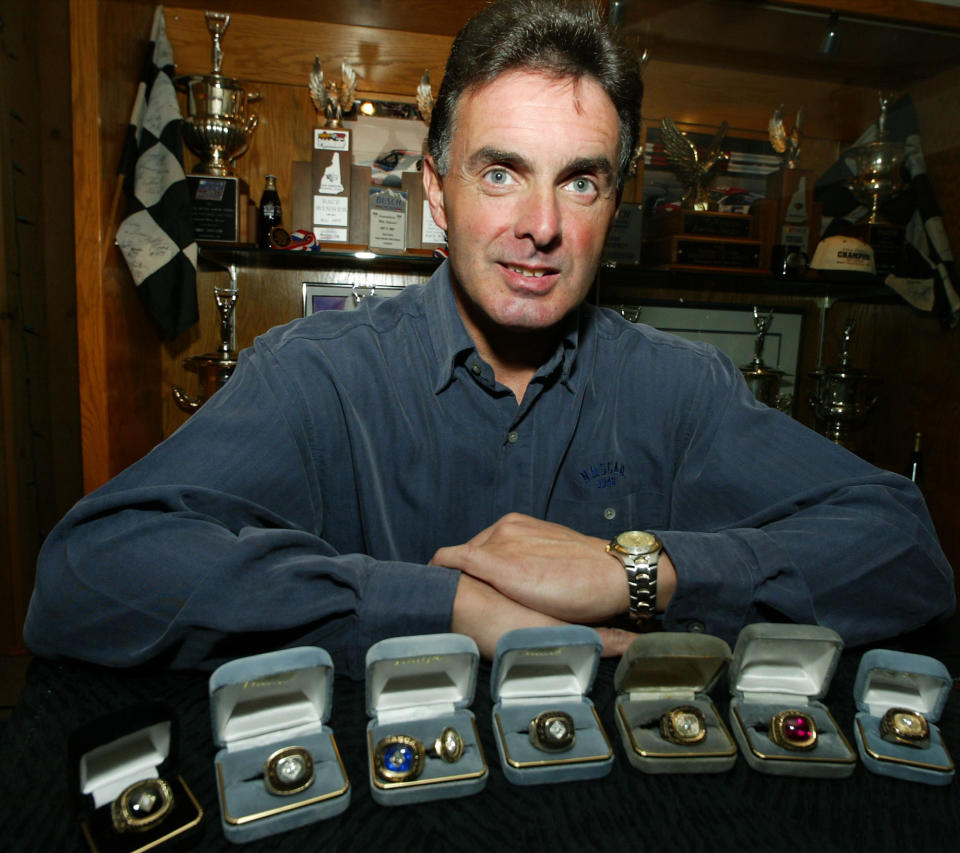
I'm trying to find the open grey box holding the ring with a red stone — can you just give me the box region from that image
[729,623,857,778]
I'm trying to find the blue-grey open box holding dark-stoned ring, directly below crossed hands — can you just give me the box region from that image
[490,625,613,785]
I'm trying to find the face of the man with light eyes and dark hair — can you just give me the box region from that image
[424,71,620,346]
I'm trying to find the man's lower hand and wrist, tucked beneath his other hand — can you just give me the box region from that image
[450,574,638,659]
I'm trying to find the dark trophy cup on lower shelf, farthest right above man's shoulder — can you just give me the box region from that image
[808,320,877,450]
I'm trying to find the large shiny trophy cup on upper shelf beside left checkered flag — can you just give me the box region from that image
[177,12,260,177]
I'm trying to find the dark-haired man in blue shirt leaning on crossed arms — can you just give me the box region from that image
[26,0,954,676]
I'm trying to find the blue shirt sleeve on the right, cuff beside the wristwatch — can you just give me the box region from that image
[658,342,955,645]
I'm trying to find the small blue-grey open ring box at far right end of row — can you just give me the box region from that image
[853,649,954,785]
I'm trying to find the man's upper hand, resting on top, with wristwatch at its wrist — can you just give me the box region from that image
[430,513,630,624]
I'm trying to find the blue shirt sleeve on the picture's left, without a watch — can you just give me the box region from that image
[25,334,459,677]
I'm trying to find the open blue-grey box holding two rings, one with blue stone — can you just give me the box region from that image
[366,634,490,806]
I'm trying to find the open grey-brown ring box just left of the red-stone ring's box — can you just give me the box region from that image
[613,632,737,773]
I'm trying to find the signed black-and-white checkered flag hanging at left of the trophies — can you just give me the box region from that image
[117,6,199,340]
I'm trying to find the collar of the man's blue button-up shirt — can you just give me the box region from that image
[424,260,583,394]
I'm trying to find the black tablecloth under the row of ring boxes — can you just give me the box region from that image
[0,650,960,853]
